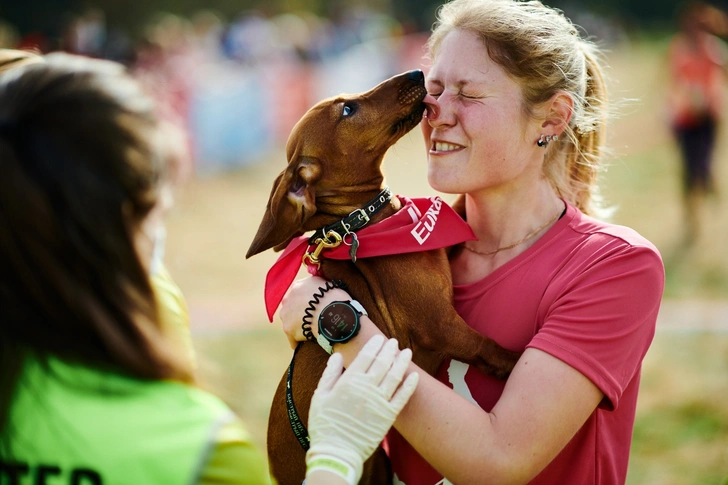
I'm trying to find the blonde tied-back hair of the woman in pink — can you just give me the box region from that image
[428,0,609,216]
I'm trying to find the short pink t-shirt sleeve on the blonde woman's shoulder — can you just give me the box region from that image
[527,236,664,410]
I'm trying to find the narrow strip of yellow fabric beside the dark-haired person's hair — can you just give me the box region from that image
[151,266,196,367]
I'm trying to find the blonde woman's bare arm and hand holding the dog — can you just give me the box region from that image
[281,278,603,484]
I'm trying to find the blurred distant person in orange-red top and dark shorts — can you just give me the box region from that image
[667,2,728,243]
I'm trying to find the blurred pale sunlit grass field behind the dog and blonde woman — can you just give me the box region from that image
[167,38,728,485]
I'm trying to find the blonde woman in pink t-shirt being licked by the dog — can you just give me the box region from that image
[280,0,665,485]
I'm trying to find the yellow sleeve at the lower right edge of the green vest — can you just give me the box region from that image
[198,420,275,485]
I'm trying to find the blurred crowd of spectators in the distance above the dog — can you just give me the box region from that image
[0,8,436,177]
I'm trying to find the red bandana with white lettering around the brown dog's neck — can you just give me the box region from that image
[265,196,476,322]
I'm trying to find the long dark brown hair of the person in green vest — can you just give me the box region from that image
[0,54,191,434]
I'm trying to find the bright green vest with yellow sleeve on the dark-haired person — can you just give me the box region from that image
[0,359,270,485]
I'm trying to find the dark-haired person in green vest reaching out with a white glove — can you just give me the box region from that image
[0,54,417,485]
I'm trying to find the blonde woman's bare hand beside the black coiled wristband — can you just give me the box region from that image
[279,276,351,349]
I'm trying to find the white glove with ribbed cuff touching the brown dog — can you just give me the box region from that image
[306,335,419,485]
